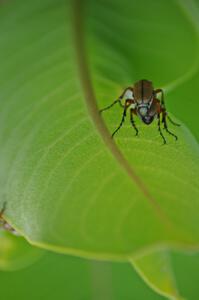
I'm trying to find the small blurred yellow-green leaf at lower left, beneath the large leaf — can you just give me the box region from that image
[0,231,43,271]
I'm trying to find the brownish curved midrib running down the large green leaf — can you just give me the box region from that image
[72,0,173,230]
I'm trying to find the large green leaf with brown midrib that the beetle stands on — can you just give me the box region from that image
[0,0,199,296]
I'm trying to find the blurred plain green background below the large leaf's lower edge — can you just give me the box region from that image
[0,252,199,300]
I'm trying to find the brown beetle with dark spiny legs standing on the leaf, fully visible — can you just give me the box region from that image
[100,79,180,144]
